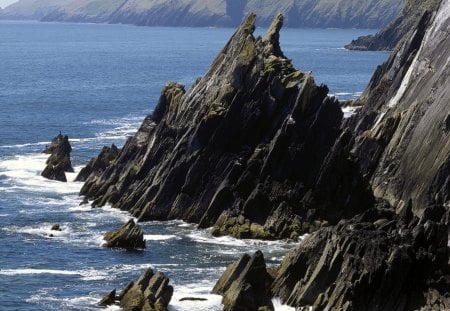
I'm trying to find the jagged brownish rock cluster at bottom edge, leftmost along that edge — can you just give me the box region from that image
[99,268,173,311]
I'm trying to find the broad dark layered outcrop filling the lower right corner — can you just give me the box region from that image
[272,207,450,311]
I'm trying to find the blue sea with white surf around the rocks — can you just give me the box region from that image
[0,21,388,311]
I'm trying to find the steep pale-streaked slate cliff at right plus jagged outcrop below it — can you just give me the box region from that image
[272,0,450,310]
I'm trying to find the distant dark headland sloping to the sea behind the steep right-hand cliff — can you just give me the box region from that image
[345,0,440,51]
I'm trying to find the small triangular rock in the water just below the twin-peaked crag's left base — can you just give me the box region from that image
[103,219,145,249]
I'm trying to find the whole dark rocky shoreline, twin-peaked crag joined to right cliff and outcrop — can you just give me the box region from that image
[65,0,450,310]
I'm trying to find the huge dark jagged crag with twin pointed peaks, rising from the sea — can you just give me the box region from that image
[81,15,354,239]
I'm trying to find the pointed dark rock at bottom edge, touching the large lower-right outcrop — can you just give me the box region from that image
[212,251,274,311]
